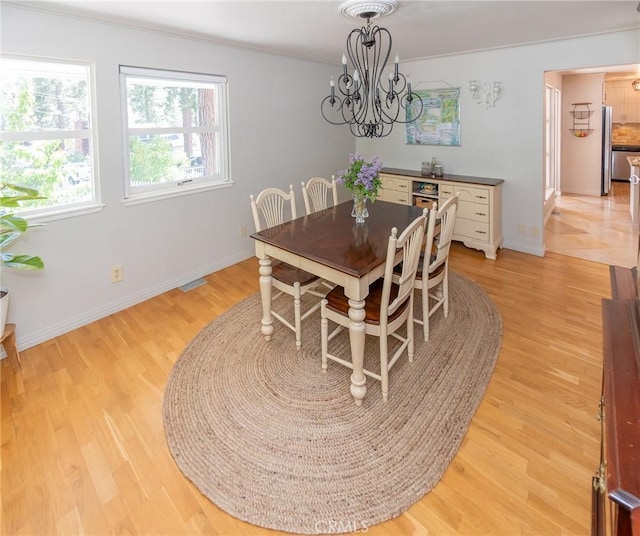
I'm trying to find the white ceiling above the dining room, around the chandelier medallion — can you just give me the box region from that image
[11,0,640,64]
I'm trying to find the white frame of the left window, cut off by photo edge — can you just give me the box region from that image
[0,54,104,222]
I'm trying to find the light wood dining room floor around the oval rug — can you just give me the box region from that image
[0,244,610,536]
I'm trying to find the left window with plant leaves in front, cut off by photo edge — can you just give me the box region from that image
[0,56,97,214]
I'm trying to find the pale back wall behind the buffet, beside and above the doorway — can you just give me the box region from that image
[357,30,640,255]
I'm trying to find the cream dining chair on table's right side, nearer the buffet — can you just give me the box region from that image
[414,195,458,341]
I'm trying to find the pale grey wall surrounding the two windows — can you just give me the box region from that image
[0,5,355,349]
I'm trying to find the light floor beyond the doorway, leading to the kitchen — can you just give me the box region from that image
[544,181,638,268]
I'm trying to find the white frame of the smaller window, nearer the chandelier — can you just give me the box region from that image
[120,65,233,205]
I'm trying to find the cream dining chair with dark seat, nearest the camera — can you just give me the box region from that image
[320,209,426,402]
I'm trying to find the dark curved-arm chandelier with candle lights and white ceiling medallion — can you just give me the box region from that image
[320,0,423,138]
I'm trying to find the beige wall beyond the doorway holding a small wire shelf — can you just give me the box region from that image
[560,73,604,195]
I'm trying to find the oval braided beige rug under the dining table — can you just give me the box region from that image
[163,272,502,534]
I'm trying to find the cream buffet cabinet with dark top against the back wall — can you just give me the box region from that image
[378,168,504,260]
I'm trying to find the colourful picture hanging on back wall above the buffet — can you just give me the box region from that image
[406,87,460,145]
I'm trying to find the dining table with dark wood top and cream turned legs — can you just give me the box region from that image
[251,201,426,406]
